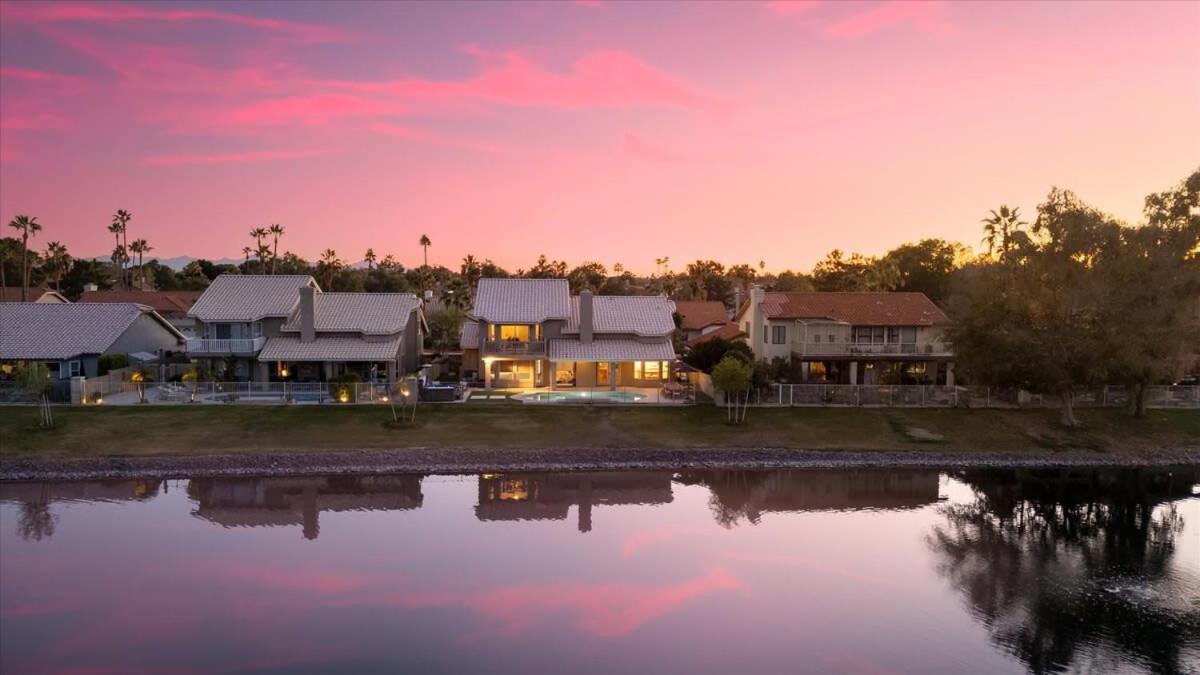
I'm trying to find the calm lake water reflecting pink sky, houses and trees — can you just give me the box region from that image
[0,467,1200,675]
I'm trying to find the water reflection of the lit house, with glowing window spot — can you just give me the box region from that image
[475,471,672,532]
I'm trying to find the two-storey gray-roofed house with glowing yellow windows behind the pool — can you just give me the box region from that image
[462,279,676,389]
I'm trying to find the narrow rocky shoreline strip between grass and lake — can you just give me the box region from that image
[0,448,1200,482]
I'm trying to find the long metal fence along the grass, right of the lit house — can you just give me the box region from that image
[718,384,1200,408]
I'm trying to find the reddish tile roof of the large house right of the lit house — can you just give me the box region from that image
[762,292,950,325]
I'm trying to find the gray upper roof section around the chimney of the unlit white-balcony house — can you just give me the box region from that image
[281,293,421,335]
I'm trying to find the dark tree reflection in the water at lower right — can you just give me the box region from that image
[929,468,1200,673]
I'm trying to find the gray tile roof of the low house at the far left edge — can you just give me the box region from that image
[0,303,184,360]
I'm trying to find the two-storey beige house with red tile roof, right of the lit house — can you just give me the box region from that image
[734,287,954,384]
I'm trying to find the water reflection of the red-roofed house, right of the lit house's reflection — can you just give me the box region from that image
[680,470,938,525]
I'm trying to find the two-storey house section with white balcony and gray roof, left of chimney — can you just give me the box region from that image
[187,274,317,381]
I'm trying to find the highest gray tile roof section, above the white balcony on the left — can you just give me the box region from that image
[187,274,316,322]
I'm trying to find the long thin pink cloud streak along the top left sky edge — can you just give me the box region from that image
[5,2,347,42]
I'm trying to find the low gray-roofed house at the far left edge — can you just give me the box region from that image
[0,303,185,380]
